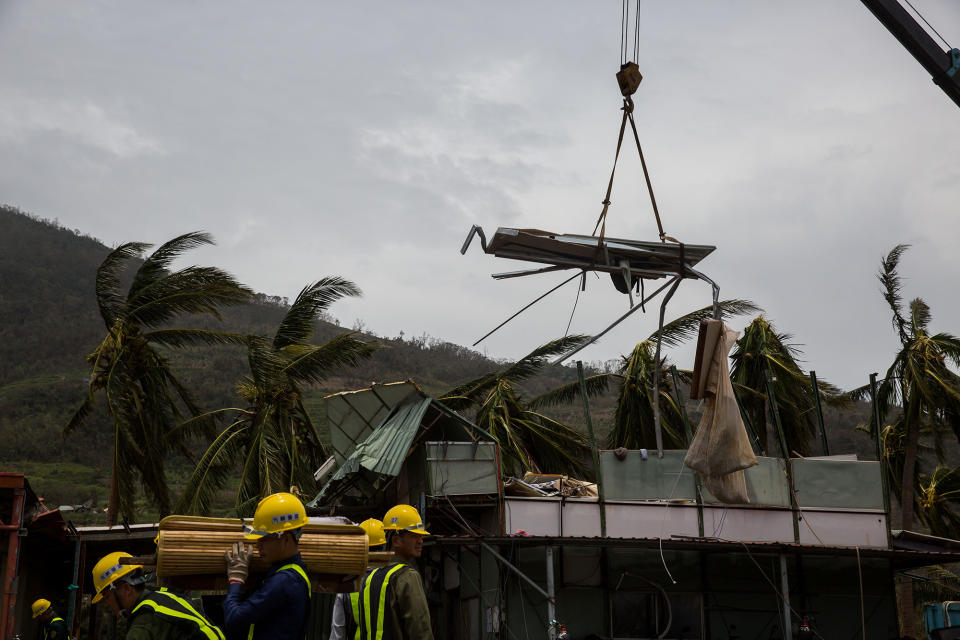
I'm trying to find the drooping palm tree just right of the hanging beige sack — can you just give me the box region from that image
[730,315,842,457]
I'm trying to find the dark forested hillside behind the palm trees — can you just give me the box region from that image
[0,206,916,515]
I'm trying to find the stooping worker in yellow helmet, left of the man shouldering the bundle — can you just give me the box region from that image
[92,551,224,640]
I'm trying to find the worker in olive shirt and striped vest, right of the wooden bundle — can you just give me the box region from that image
[356,504,433,640]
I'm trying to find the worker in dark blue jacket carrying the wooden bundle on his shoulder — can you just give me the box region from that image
[223,493,311,640]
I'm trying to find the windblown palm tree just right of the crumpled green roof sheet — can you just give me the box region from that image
[440,335,606,477]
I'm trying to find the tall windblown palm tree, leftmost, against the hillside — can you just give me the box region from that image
[64,232,250,525]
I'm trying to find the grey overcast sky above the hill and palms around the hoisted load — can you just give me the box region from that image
[0,0,960,388]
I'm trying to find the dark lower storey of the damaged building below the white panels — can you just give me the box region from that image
[438,545,897,640]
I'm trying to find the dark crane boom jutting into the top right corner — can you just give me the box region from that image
[861,0,960,107]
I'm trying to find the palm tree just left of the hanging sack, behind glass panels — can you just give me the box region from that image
[607,300,760,449]
